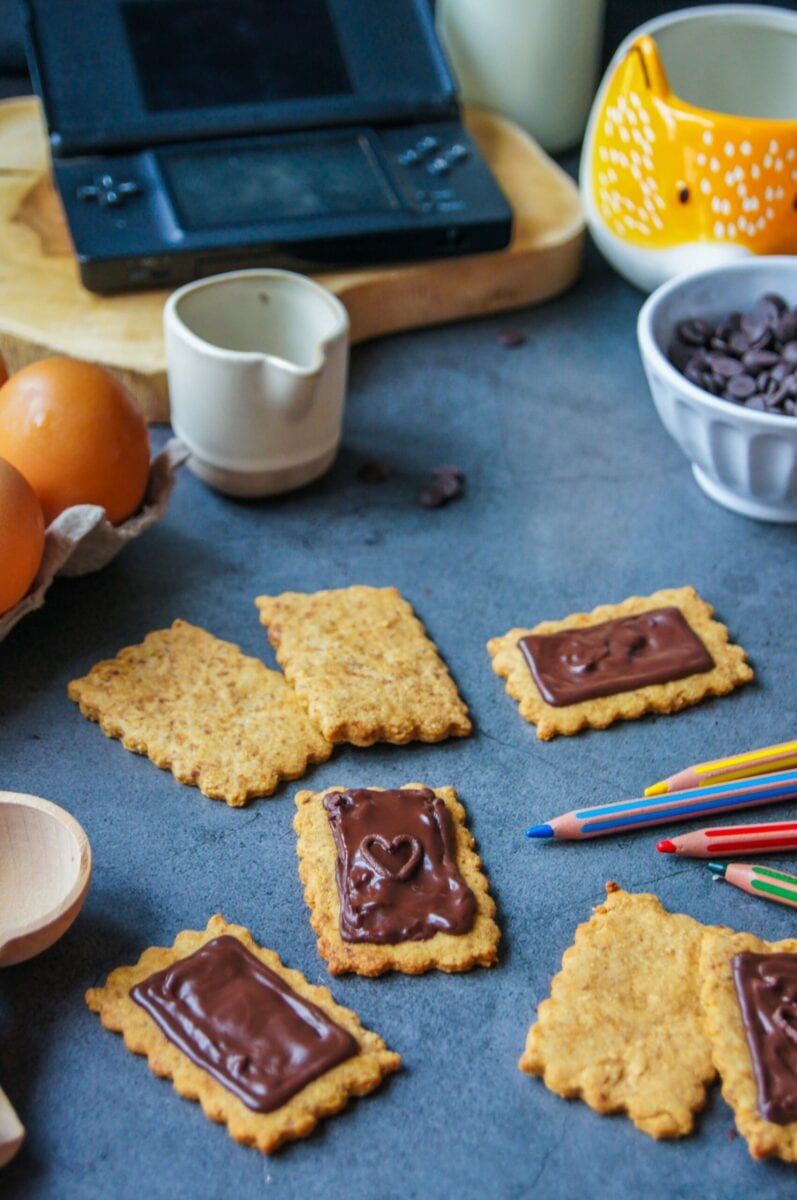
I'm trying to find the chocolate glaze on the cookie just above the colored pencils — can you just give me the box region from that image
[517,607,714,707]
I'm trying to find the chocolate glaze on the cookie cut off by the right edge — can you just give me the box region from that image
[732,952,797,1124]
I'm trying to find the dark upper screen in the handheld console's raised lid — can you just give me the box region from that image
[121,0,353,113]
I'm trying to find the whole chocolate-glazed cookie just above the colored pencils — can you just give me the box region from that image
[487,588,753,740]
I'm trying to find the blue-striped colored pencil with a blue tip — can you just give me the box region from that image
[526,770,797,839]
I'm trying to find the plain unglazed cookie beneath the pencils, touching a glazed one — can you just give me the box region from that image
[520,883,714,1139]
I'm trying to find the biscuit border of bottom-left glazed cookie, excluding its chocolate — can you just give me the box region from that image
[85,916,401,1154]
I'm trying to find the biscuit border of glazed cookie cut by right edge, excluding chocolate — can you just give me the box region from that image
[700,929,797,1163]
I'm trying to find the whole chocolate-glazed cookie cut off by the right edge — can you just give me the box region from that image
[700,929,797,1163]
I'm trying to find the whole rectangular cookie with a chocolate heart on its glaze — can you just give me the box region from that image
[294,784,501,976]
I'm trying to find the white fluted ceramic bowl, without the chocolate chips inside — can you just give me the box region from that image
[637,256,797,522]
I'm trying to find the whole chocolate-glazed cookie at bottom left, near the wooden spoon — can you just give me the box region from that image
[85,916,401,1154]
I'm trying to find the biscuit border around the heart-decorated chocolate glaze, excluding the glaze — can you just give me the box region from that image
[294,784,501,976]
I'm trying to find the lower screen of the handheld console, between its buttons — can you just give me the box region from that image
[157,134,401,229]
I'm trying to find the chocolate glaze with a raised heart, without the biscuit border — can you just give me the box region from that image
[324,787,477,943]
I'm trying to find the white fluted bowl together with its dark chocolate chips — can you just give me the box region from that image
[637,256,797,522]
